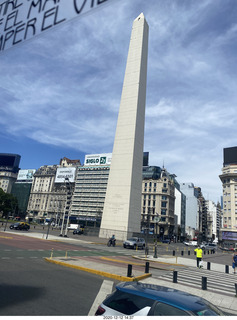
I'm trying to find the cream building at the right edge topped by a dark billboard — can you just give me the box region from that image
[219,147,237,242]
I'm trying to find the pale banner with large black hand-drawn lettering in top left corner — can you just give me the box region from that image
[0,0,112,51]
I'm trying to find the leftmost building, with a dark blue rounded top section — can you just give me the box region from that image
[0,153,21,193]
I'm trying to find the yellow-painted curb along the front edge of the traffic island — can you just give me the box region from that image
[45,258,151,281]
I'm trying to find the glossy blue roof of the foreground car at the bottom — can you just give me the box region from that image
[116,282,208,311]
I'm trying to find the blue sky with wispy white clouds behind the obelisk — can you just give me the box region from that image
[0,0,237,202]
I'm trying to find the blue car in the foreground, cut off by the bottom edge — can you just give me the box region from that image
[95,281,225,317]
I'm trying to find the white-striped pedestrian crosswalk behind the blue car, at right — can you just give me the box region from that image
[159,268,237,296]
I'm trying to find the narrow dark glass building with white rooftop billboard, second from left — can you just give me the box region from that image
[11,169,36,218]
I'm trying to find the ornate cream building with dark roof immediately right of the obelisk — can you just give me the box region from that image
[141,167,175,239]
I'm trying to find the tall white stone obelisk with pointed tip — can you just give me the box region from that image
[99,13,149,240]
